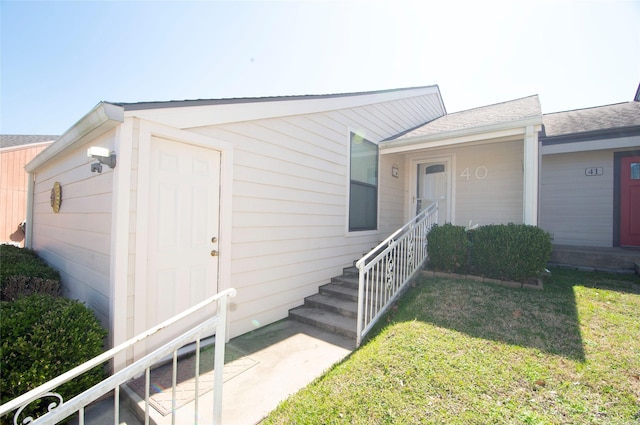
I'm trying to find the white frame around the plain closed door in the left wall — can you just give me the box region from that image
[133,120,233,344]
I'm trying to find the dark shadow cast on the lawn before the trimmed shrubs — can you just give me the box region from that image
[372,270,608,361]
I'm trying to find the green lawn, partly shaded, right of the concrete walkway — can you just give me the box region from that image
[264,269,640,424]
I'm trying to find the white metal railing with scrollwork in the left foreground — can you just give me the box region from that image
[0,289,236,425]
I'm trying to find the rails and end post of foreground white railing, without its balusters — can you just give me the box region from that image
[0,288,236,425]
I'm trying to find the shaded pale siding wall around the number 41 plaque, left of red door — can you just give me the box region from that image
[540,150,614,246]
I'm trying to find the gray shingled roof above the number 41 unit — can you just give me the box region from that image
[541,102,640,138]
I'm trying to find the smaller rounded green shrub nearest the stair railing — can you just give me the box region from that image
[427,223,468,272]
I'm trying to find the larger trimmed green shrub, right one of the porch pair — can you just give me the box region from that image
[471,224,553,281]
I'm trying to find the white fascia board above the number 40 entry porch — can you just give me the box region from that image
[379,117,542,154]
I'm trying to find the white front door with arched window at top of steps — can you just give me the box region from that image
[414,160,451,225]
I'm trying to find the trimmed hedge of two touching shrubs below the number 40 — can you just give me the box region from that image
[427,223,553,282]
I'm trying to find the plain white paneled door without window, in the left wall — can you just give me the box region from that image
[146,137,220,344]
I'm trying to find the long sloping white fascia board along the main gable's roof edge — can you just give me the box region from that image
[124,86,445,129]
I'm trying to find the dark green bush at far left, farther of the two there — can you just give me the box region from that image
[0,245,60,301]
